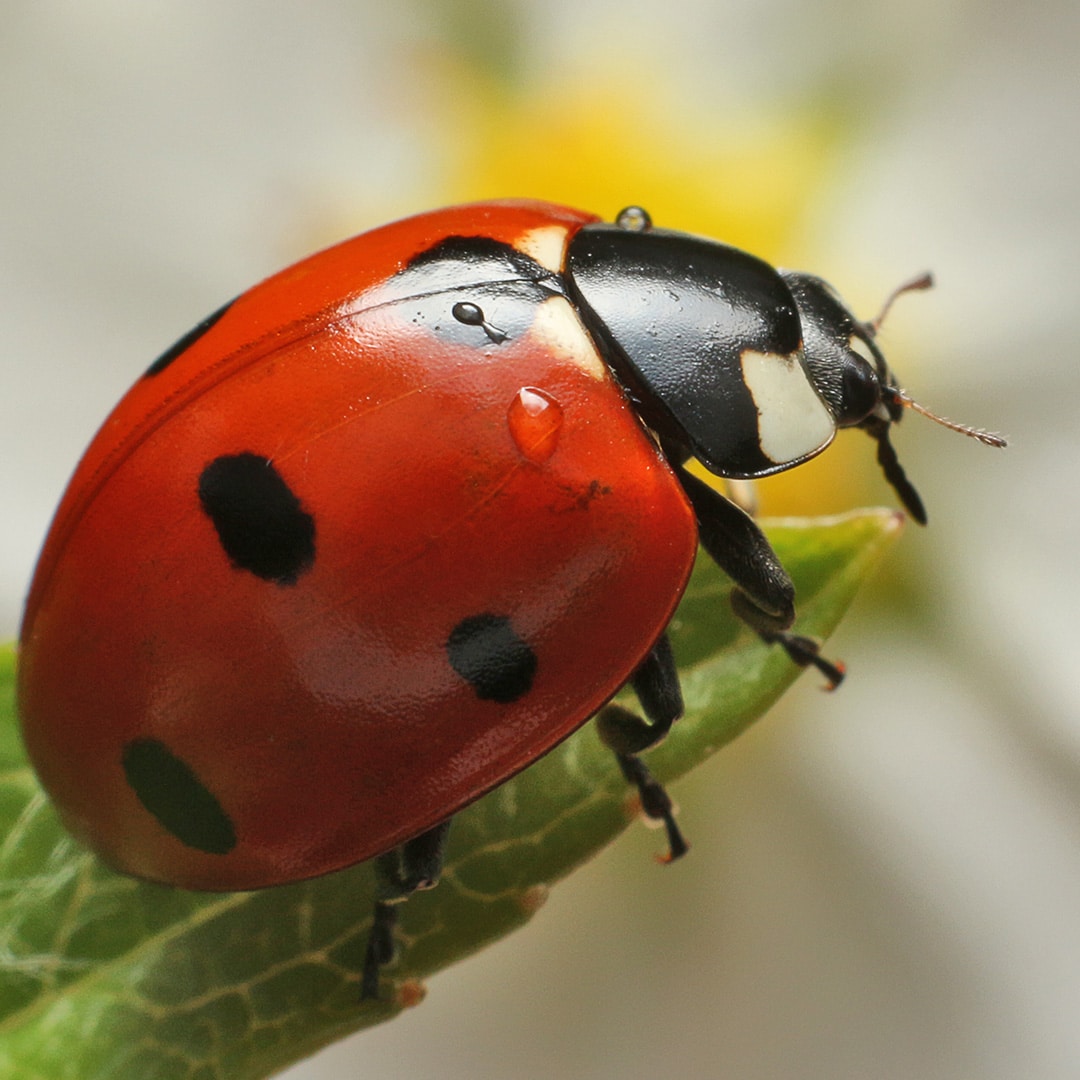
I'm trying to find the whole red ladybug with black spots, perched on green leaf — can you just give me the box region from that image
[17,201,995,997]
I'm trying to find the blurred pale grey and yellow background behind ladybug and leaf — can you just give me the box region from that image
[0,0,1080,1080]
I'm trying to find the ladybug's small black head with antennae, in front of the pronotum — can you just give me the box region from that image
[780,270,1005,525]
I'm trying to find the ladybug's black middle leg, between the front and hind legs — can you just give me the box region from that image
[596,634,688,861]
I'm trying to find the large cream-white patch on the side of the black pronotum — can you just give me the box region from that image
[741,349,836,465]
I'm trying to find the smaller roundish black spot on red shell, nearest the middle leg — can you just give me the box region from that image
[446,613,537,705]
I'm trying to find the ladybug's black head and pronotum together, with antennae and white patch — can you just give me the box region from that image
[564,206,1001,522]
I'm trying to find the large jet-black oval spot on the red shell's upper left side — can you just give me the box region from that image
[199,454,315,585]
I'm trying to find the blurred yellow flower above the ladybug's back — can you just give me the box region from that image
[437,66,836,258]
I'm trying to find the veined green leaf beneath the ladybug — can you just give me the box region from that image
[0,511,901,1080]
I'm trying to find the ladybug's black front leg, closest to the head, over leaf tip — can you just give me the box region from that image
[677,469,843,688]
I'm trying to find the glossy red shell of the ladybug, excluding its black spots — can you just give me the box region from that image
[18,202,697,889]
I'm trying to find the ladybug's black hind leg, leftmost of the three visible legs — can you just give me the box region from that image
[360,819,450,1001]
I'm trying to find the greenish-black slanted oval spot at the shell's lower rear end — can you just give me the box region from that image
[121,739,237,855]
